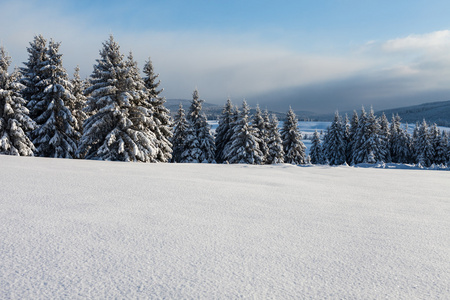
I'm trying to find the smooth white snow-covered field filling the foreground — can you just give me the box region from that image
[0,156,450,299]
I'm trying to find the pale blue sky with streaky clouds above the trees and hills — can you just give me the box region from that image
[0,0,450,113]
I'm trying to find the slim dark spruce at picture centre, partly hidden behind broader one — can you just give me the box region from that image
[215,98,235,163]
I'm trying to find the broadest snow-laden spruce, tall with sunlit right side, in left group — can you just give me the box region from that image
[78,36,157,162]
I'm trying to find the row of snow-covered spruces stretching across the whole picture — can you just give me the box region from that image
[0,35,450,167]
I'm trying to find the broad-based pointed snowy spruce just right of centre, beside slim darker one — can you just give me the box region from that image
[226,100,263,165]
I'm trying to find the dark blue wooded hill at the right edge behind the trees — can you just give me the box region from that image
[376,101,450,127]
